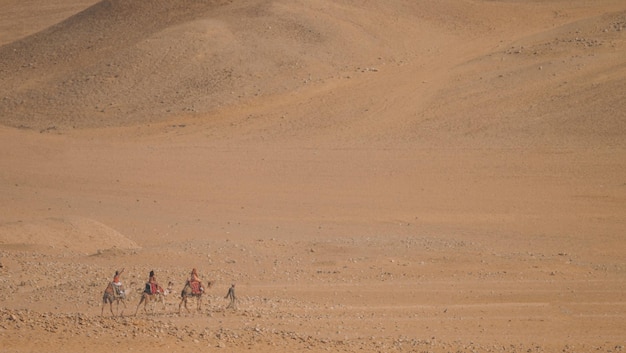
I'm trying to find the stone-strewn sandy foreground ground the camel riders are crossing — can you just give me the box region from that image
[0,227,626,352]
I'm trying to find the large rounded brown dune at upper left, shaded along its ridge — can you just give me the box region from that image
[0,1,414,129]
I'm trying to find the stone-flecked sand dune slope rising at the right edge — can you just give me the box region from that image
[414,12,626,145]
